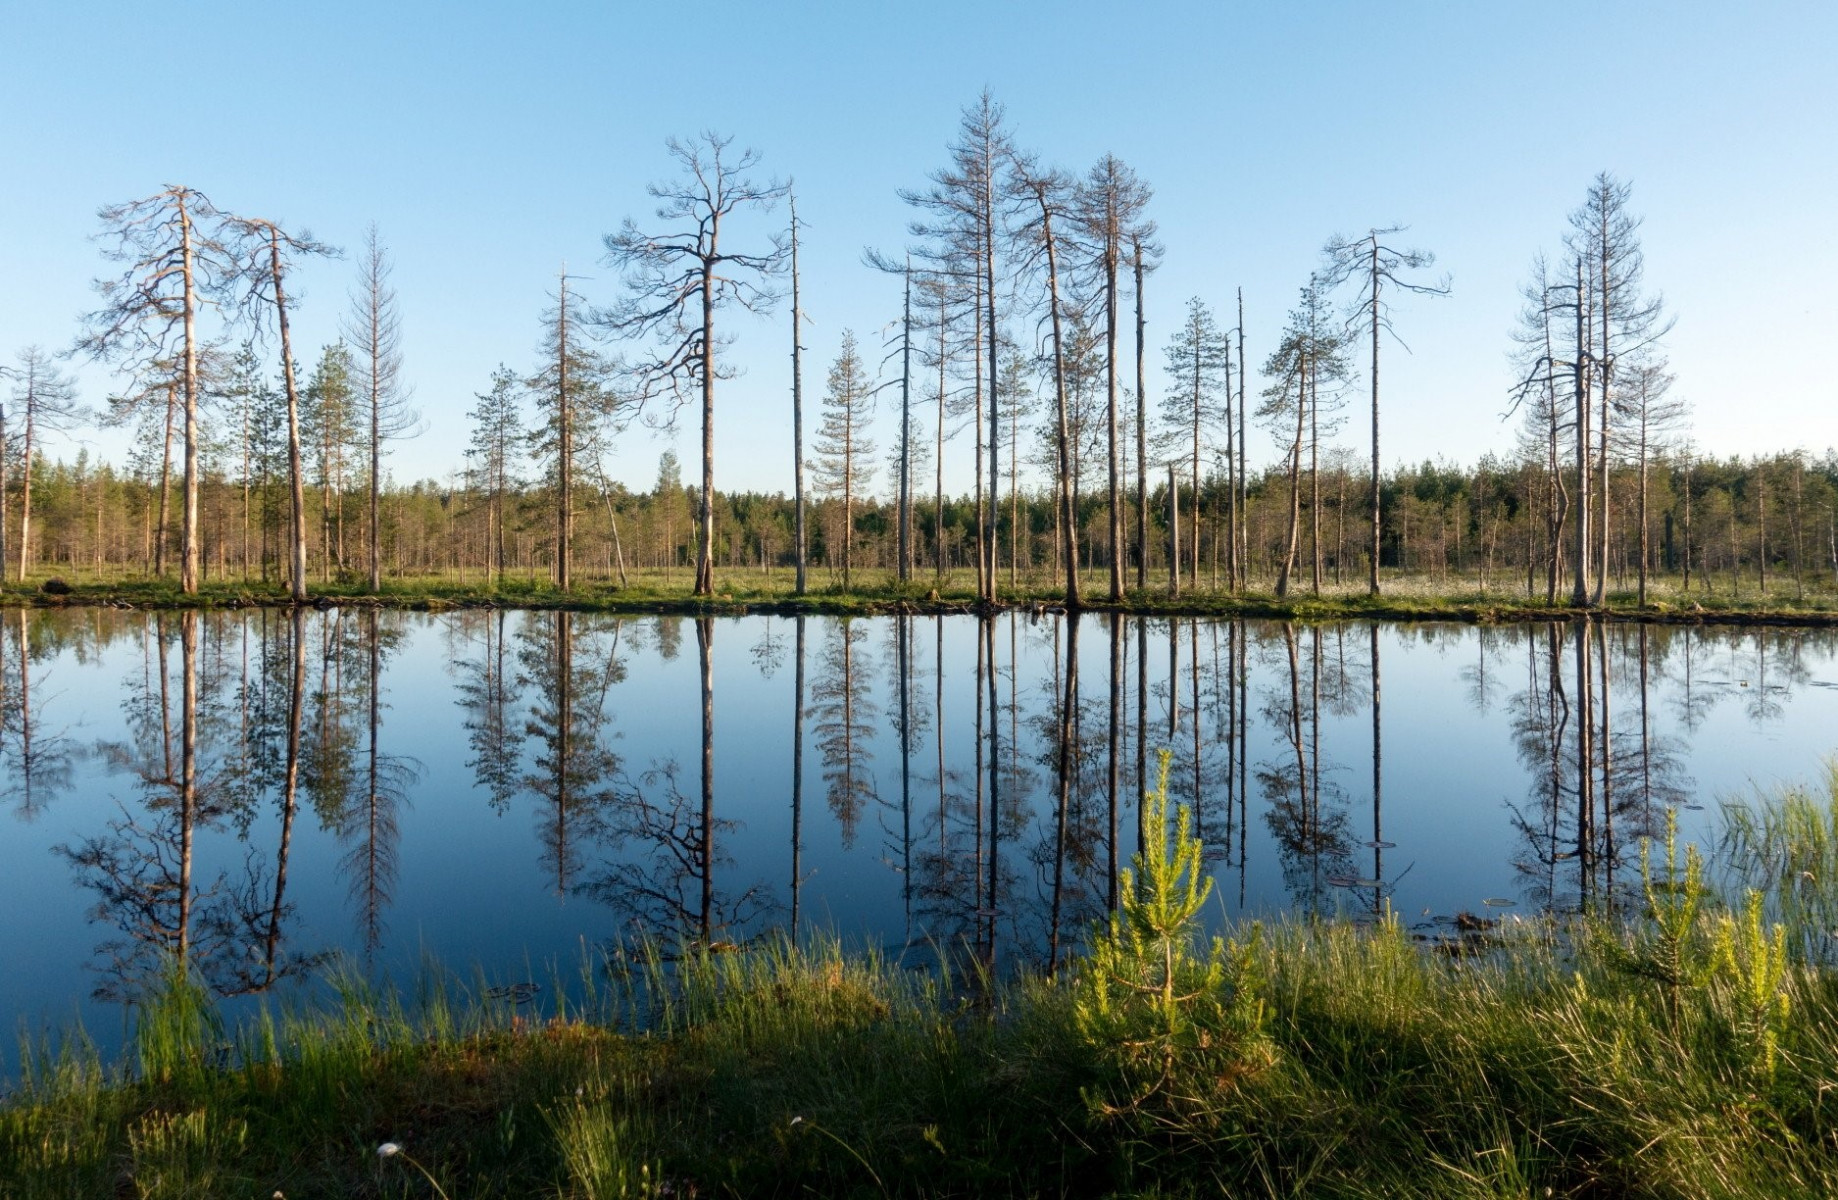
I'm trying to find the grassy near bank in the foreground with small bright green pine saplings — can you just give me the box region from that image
[0,777,1838,1200]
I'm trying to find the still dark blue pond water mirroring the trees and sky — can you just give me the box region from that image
[0,610,1838,1046]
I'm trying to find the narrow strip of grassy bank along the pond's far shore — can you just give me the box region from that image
[0,570,1838,625]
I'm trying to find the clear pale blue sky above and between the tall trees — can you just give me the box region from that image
[0,0,1838,491]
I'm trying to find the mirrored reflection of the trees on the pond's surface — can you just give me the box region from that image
[17,608,1838,996]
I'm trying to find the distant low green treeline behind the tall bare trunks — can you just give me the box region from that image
[13,450,1838,599]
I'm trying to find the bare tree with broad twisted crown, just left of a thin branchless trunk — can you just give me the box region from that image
[597,132,790,595]
